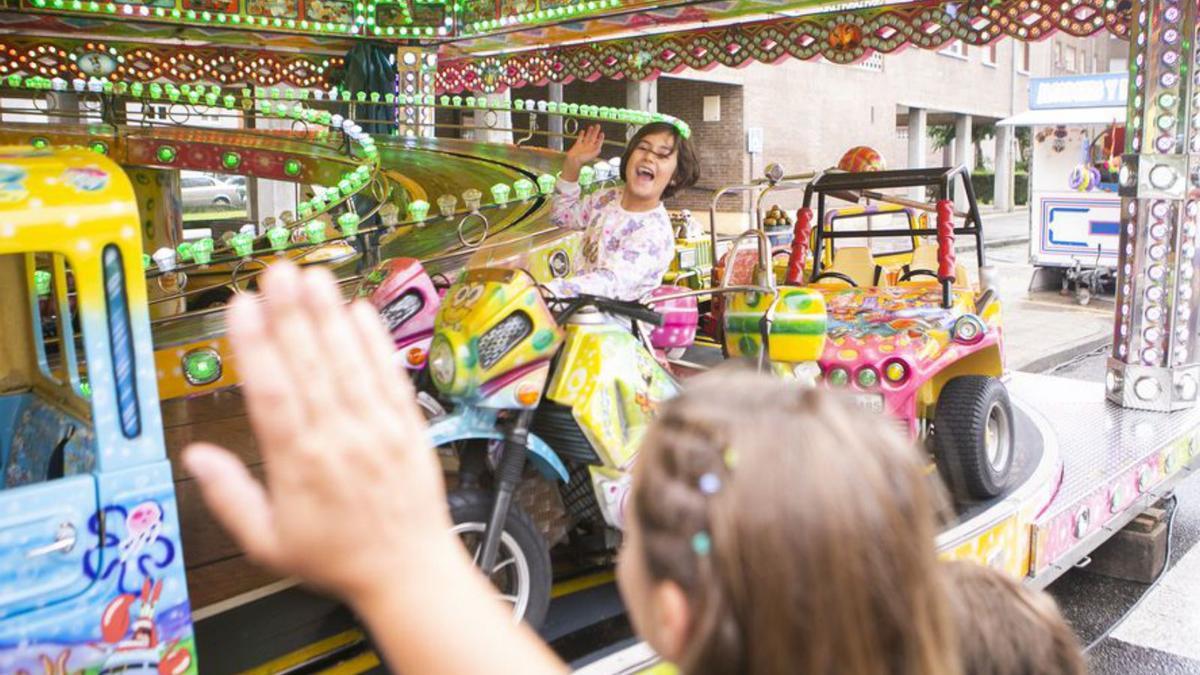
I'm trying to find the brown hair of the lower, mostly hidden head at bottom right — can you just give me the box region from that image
[944,562,1086,675]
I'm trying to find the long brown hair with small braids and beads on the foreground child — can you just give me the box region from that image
[632,368,958,675]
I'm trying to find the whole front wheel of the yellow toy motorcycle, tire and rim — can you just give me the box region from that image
[448,490,553,628]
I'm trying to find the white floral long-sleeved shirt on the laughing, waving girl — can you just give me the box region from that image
[546,179,674,300]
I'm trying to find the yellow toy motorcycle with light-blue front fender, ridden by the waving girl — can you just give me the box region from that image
[428,269,678,626]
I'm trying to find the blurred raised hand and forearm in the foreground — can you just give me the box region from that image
[184,263,564,673]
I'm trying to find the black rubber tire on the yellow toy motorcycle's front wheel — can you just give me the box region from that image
[446,490,554,629]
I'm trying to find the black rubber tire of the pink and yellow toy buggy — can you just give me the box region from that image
[934,375,1016,501]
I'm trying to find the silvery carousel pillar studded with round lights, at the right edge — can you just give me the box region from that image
[1105,0,1200,412]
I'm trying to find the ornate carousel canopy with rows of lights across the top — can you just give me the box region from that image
[0,0,1130,92]
